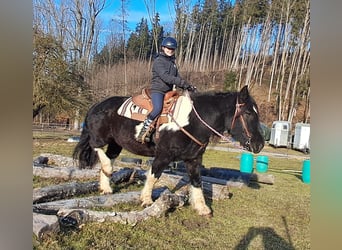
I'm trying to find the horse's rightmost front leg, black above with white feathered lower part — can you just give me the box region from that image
[185,159,212,215]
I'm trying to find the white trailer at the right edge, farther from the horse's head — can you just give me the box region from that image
[293,123,310,152]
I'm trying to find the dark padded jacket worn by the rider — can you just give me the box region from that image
[151,52,182,93]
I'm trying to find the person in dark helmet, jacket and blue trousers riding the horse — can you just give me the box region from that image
[136,37,196,142]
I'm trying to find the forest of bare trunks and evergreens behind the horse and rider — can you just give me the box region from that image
[33,0,311,129]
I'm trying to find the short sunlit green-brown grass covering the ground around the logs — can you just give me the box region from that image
[33,132,310,249]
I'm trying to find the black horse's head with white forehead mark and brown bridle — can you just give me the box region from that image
[230,86,265,153]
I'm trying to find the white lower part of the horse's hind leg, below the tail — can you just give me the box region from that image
[94,148,113,194]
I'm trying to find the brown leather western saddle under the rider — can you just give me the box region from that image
[132,88,180,124]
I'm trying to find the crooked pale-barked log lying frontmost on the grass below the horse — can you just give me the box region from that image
[57,189,185,227]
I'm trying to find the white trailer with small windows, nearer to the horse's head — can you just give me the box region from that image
[269,121,291,147]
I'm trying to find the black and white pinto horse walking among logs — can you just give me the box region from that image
[73,86,264,215]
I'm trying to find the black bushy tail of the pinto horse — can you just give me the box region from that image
[73,122,98,169]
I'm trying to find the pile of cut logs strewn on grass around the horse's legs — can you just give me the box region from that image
[33,155,274,238]
